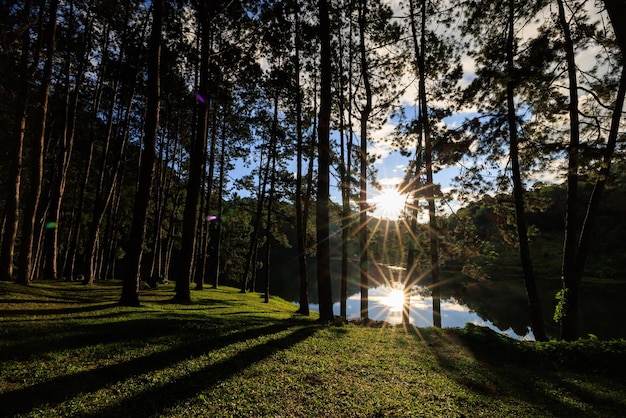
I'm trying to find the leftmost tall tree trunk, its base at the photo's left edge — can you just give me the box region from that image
[0,1,31,280]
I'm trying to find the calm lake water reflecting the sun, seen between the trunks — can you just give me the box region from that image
[276,261,626,340]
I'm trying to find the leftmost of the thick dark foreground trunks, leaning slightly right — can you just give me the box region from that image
[119,0,163,306]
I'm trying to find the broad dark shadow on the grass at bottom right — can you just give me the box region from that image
[422,324,626,417]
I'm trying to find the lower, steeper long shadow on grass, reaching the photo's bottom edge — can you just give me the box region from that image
[83,326,318,418]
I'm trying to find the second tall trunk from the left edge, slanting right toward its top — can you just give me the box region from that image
[18,0,59,284]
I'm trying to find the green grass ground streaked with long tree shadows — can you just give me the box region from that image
[0,282,626,417]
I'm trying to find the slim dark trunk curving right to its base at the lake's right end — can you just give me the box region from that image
[506,0,547,341]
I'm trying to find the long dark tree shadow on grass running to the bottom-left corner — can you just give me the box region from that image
[0,320,317,416]
